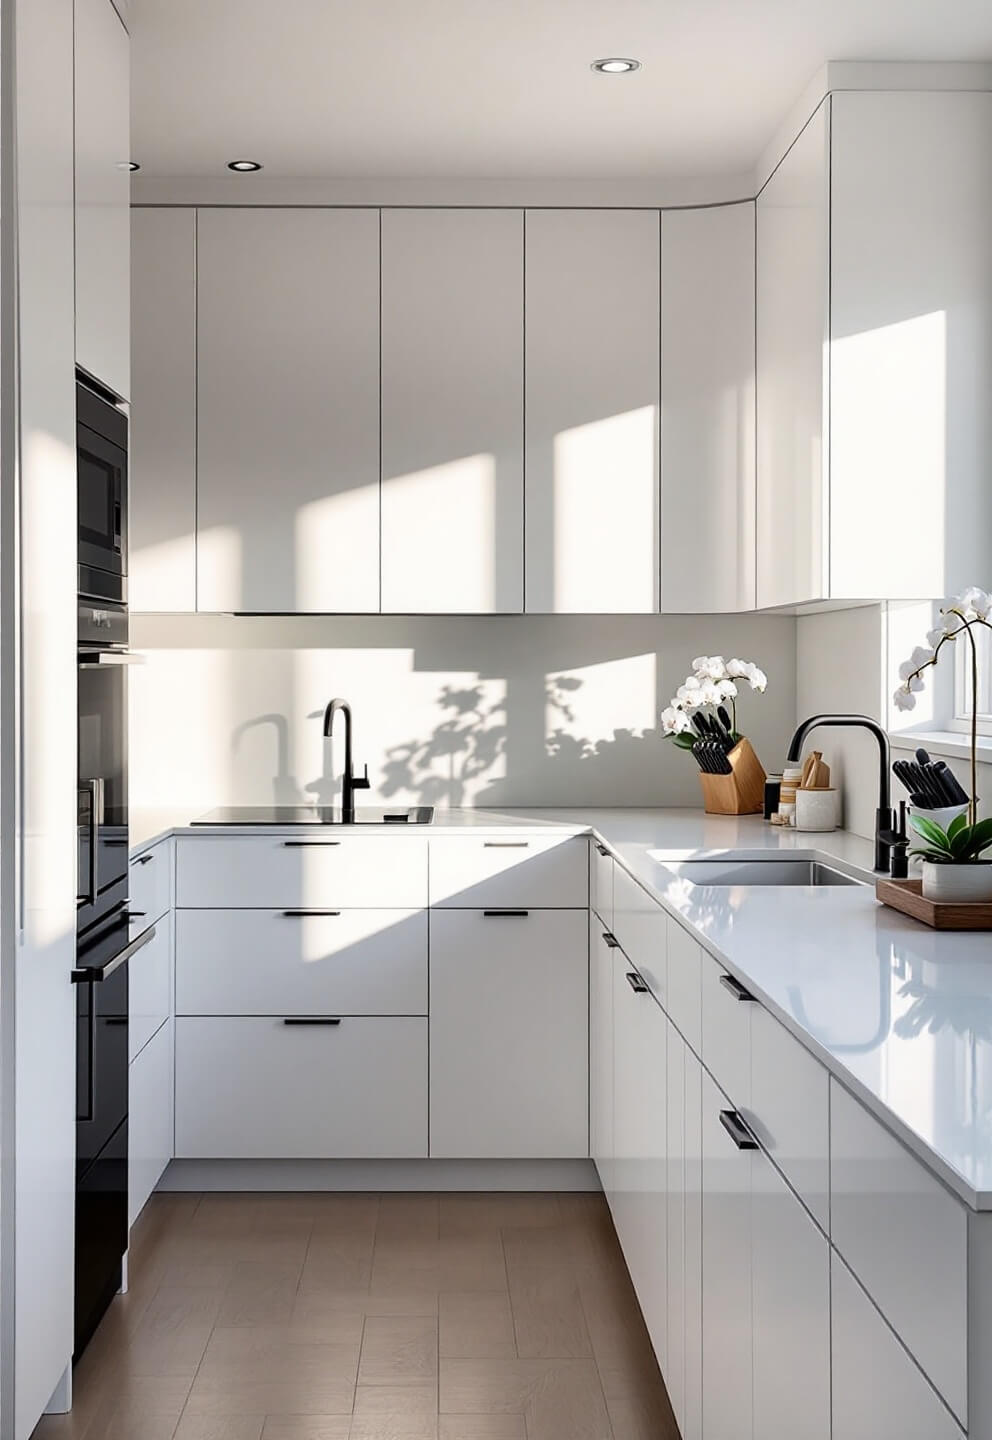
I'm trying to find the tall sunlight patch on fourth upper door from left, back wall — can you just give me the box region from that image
[553,405,658,615]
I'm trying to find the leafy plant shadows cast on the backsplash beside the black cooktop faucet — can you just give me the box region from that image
[374,675,659,806]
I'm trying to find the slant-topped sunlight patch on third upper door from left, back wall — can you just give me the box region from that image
[383,454,498,613]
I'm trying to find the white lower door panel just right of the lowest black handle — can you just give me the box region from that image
[752,1151,829,1440]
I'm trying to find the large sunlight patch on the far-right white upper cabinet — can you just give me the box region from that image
[831,310,947,598]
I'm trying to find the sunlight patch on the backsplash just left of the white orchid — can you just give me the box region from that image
[544,652,658,763]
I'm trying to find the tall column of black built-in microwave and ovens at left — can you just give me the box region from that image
[72,384,145,1358]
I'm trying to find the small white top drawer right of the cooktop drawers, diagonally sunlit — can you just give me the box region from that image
[430,835,589,910]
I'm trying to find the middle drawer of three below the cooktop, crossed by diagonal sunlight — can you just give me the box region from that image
[176,910,428,1015]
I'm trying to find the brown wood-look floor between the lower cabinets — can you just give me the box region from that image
[35,1194,678,1440]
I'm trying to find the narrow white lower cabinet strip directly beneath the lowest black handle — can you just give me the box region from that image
[703,1071,748,1440]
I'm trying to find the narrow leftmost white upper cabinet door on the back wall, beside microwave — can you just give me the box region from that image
[128,207,196,611]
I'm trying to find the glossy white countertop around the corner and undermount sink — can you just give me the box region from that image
[132,806,992,1210]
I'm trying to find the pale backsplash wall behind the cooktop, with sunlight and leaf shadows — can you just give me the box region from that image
[131,615,796,811]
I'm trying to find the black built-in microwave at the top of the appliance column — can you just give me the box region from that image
[76,379,128,602]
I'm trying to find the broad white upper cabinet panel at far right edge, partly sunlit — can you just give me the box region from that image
[829,92,992,599]
